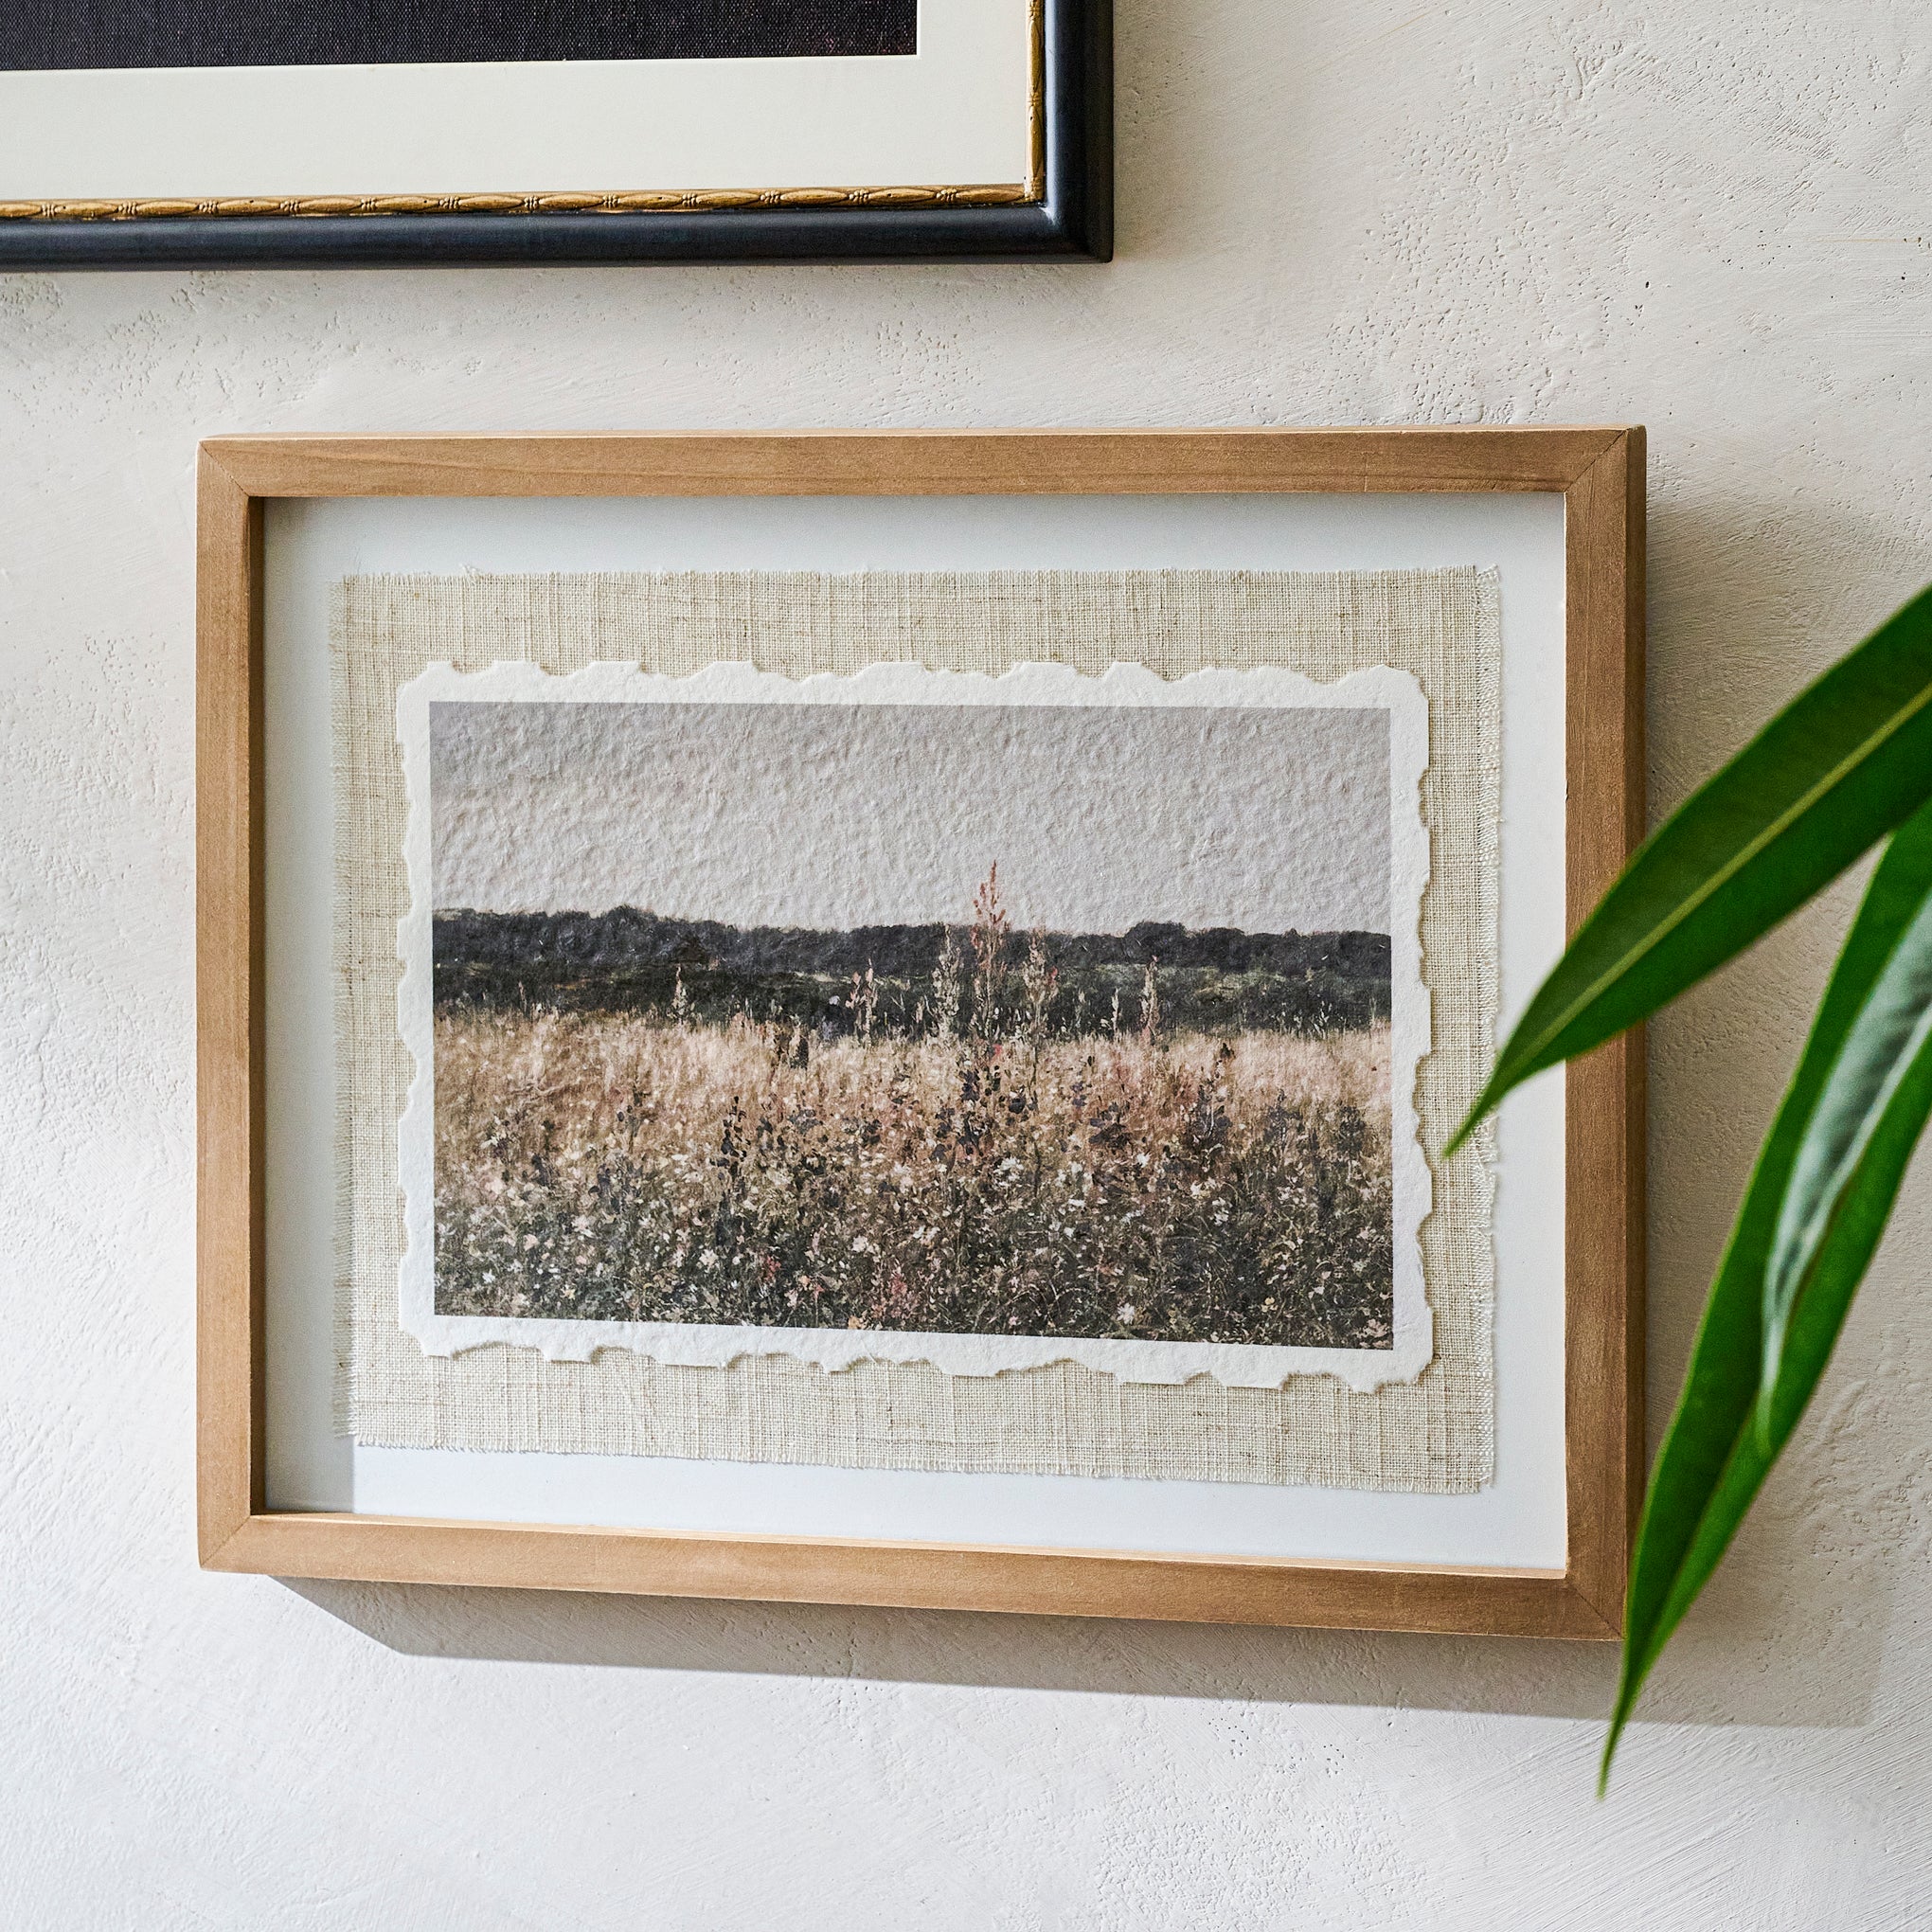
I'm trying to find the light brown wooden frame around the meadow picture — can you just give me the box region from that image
[195,427,1644,1638]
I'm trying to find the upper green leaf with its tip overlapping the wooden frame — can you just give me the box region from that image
[1445,589,1932,1152]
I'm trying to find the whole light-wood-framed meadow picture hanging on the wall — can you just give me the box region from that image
[197,429,1642,1637]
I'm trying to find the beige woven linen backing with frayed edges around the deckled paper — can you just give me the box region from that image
[331,570,1501,1494]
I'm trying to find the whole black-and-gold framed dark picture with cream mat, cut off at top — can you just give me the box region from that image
[0,0,1111,269]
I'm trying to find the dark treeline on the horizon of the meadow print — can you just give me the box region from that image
[435,906,1389,1037]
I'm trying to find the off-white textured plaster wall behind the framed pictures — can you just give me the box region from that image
[0,0,1932,1932]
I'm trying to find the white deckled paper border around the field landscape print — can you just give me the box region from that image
[396,663,1434,1391]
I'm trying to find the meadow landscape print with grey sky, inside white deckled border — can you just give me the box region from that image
[403,664,1437,1360]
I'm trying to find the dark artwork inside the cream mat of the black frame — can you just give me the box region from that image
[0,0,918,71]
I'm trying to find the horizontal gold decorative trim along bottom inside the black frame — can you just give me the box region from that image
[0,176,1044,223]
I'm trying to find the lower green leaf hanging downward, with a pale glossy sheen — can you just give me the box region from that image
[1603,806,1932,1780]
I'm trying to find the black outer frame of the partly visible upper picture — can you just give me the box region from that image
[0,0,1113,273]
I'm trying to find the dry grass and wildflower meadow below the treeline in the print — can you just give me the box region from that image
[435,1004,1393,1349]
